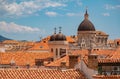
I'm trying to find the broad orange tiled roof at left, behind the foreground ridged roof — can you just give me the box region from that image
[0,52,53,66]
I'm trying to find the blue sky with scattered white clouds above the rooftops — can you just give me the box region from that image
[0,0,120,40]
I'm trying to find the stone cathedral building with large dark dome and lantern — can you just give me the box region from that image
[77,10,109,49]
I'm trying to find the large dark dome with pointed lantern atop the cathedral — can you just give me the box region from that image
[78,10,95,31]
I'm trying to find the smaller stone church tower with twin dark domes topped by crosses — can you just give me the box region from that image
[48,27,69,60]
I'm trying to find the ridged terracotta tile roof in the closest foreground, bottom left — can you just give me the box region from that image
[0,69,86,79]
